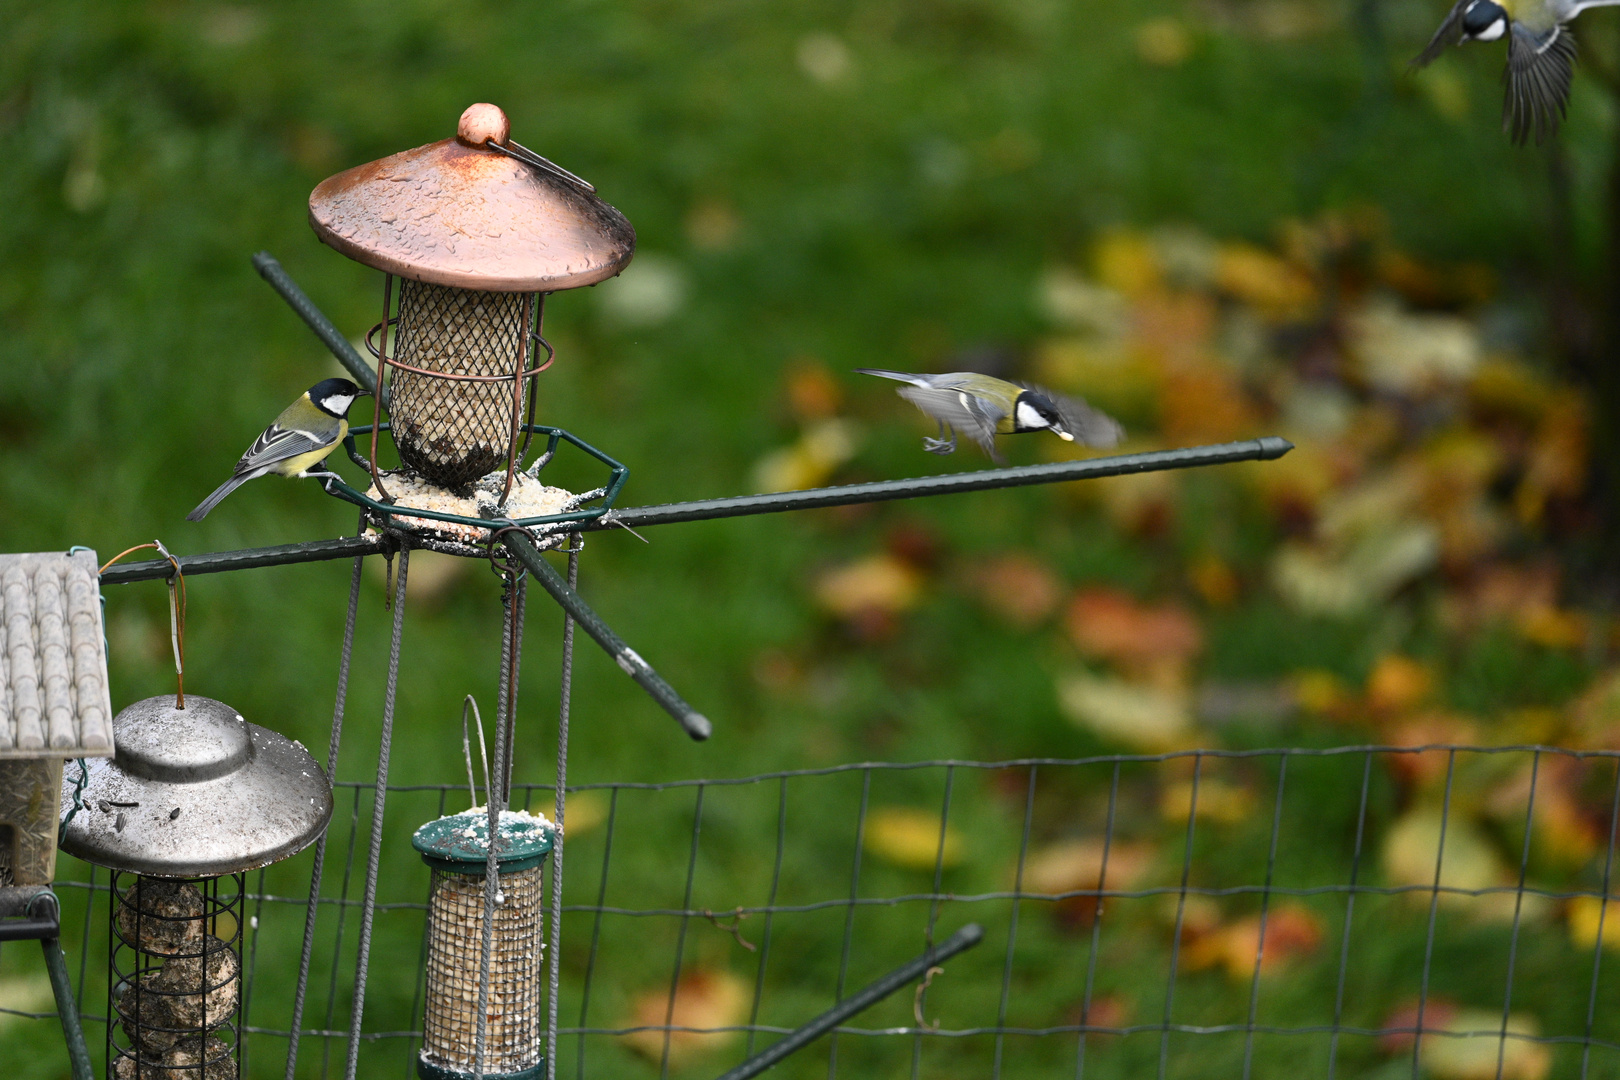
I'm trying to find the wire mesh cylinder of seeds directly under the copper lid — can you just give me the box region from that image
[389,279,535,487]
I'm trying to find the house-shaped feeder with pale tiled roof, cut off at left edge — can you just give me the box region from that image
[0,549,113,887]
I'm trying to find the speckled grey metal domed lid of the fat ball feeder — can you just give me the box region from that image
[62,695,332,878]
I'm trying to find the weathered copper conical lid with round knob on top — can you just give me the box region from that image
[309,104,635,293]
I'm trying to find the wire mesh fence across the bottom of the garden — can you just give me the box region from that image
[9,746,1620,1080]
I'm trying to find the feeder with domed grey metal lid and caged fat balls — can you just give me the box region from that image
[62,695,332,1080]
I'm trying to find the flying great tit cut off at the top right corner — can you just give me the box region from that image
[1413,0,1587,146]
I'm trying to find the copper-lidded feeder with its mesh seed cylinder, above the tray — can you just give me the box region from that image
[309,104,635,505]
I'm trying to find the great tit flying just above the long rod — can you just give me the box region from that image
[855,368,1124,461]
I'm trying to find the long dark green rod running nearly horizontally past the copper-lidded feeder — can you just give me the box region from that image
[100,436,1294,585]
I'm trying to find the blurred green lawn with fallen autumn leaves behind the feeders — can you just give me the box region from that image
[0,0,1620,1080]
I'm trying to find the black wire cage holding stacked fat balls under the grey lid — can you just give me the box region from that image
[107,871,245,1080]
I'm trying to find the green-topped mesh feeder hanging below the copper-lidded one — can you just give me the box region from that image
[411,806,556,1080]
